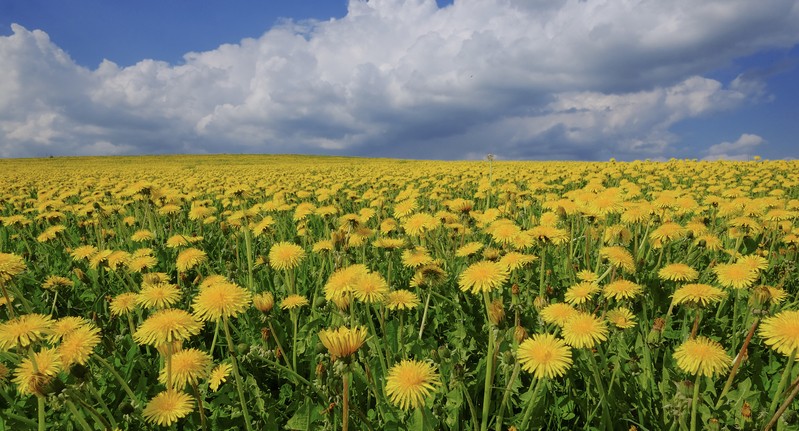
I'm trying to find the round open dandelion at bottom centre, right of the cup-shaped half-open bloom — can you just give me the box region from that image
[386,359,441,410]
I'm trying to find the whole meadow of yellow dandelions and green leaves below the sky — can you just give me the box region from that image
[0,155,799,431]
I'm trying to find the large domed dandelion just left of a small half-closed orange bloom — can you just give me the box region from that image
[191,282,250,322]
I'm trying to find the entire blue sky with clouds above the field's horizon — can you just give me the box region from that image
[0,0,799,160]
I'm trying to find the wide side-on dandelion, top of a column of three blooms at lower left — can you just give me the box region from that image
[133,309,202,347]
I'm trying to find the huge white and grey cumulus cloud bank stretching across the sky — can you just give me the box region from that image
[0,0,799,159]
